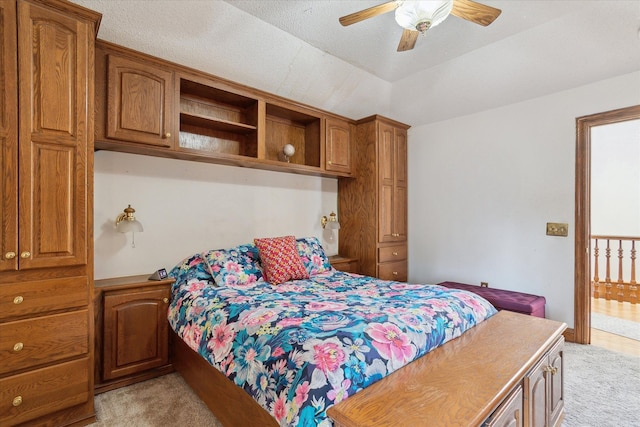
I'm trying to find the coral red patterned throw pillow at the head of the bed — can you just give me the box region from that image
[253,236,309,285]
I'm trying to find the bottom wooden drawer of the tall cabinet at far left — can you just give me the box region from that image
[0,358,90,426]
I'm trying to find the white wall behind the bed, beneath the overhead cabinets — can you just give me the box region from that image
[94,151,338,279]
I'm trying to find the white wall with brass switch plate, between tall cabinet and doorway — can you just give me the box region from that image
[409,72,640,327]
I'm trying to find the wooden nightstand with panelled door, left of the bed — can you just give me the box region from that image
[94,275,174,393]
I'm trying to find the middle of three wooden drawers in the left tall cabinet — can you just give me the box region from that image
[0,310,89,374]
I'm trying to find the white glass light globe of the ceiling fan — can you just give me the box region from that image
[395,0,453,32]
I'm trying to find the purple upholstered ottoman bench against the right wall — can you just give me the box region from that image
[438,282,547,318]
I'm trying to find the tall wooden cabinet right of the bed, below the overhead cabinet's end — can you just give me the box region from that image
[338,116,409,281]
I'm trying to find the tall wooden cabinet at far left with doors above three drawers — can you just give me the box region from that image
[0,0,100,426]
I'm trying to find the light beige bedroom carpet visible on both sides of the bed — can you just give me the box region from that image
[91,343,640,427]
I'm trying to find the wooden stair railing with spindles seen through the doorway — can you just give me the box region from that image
[591,235,640,304]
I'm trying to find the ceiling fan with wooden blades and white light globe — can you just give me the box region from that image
[340,0,502,52]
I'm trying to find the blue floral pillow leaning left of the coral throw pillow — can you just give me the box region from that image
[203,243,264,288]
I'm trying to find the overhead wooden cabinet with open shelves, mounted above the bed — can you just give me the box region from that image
[96,41,353,177]
